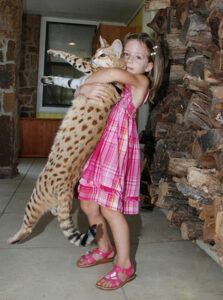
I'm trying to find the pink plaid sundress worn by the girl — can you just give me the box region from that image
[78,86,140,214]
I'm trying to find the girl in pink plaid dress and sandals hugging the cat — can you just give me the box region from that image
[77,33,162,290]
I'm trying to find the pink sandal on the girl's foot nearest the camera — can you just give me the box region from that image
[96,264,136,290]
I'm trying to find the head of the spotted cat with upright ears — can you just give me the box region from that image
[91,37,125,71]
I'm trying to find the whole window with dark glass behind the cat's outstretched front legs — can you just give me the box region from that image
[37,18,97,112]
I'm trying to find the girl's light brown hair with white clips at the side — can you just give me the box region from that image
[124,32,164,101]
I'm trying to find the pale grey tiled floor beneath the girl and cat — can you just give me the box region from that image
[0,158,223,300]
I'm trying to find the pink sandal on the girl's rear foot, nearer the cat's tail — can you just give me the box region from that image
[76,248,116,268]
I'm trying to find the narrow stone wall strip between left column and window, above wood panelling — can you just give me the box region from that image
[18,15,41,117]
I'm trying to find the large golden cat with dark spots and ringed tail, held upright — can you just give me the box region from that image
[8,40,123,245]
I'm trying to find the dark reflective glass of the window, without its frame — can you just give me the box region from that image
[42,22,96,107]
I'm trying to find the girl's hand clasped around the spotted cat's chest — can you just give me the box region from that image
[74,83,110,101]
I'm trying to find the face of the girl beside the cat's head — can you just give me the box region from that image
[123,40,153,74]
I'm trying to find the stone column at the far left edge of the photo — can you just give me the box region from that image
[0,0,23,178]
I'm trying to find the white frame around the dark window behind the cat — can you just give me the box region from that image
[36,17,99,115]
